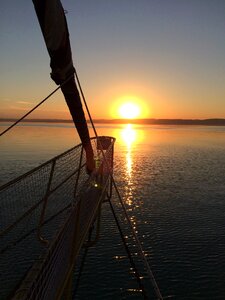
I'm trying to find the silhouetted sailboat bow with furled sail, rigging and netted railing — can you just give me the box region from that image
[0,0,162,300]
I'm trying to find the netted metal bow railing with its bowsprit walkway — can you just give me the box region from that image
[0,137,115,299]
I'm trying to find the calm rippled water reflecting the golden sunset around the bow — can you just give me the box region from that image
[0,123,225,299]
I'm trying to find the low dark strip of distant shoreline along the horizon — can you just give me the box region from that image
[0,118,225,126]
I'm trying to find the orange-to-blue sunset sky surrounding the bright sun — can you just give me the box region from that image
[0,0,225,119]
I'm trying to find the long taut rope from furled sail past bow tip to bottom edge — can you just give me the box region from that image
[75,69,163,300]
